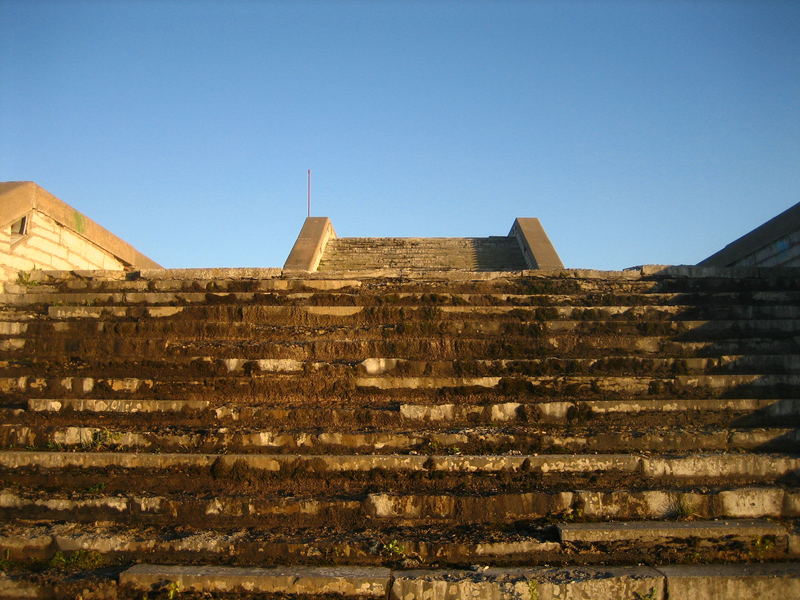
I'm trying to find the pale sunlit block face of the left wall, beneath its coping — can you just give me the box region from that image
[0,210,125,280]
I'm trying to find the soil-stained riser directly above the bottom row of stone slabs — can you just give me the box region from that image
[0,531,794,568]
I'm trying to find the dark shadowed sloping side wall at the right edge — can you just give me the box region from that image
[698,203,800,267]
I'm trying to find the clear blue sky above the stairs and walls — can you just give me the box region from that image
[0,0,800,269]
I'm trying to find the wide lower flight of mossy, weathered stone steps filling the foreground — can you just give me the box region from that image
[0,264,800,600]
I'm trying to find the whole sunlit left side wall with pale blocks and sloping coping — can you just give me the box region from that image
[0,181,159,281]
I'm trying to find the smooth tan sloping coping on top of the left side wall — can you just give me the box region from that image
[0,181,162,269]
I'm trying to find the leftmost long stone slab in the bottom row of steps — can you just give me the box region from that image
[119,564,391,598]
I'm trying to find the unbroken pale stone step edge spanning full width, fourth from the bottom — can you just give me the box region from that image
[0,451,800,482]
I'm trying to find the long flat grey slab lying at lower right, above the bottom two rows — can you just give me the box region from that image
[557,519,788,543]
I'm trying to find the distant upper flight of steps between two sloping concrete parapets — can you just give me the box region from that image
[318,236,527,272]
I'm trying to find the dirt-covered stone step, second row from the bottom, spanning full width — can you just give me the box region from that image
[0,522,797,569]
